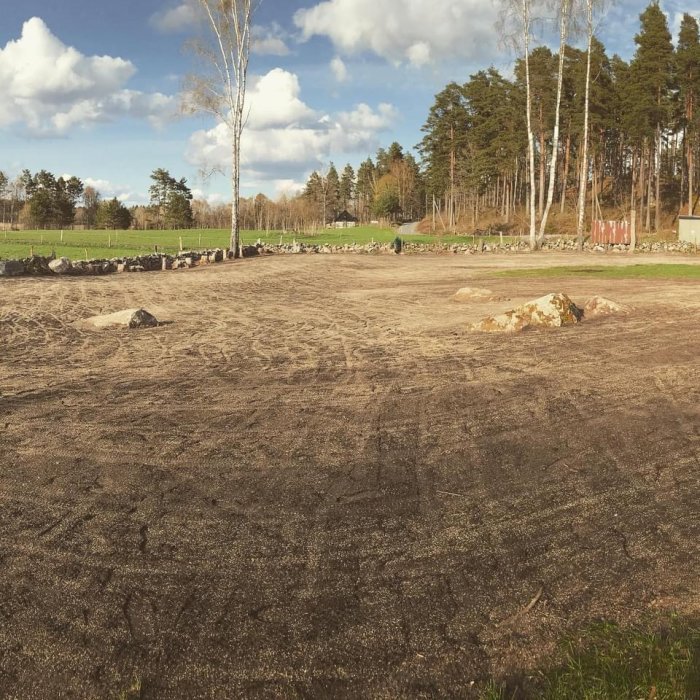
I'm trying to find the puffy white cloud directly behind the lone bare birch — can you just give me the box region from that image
[186,68,398,183]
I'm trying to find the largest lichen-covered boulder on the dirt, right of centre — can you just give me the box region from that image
[471,294,583,333]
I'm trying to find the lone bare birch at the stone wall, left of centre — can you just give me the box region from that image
[186,0,261,258]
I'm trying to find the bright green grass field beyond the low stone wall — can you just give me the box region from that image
[0,226,514,260]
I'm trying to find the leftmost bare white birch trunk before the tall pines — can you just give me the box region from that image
[499,0,537,249]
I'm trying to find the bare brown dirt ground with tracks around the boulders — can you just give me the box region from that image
[0,254,700,700]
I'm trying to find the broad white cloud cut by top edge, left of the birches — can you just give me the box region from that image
[294,0,498,67]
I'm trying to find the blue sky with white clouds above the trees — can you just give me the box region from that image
[0,0,700,204]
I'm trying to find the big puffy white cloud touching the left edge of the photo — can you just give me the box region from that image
[0,17,177,136]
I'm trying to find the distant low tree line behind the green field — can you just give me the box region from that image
[0,148,432,231]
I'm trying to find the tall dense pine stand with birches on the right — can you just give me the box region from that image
[418,0,700,243]
